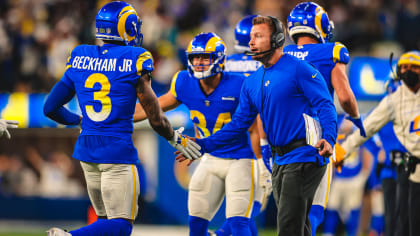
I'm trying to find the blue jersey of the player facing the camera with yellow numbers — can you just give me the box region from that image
[170,71,254,159]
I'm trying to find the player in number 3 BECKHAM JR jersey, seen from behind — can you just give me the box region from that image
[44,2,200,236]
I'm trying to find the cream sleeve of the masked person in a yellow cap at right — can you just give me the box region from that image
[341,96,392,157]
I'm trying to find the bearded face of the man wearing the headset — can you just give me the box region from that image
[249,24,271,60]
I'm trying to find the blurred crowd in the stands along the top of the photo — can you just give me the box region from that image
[0,0,420,93]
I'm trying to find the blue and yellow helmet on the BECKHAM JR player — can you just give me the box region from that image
[96,2,143,47]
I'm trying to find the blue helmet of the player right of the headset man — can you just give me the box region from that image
[287,2,334,43]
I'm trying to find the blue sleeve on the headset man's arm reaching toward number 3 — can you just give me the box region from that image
[197,81,258,152]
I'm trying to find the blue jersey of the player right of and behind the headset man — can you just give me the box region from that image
[284,42,350,97]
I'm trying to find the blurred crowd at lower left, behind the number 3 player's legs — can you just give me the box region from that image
[0,146,87,198]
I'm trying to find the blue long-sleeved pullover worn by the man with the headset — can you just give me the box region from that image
[198,54,337,165]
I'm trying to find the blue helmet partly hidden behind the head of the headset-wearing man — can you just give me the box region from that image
[235,15,257,52]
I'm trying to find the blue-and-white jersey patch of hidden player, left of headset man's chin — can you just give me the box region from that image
[225,53,261,76]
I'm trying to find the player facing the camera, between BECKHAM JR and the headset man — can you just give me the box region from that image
[134,33,257,236]
